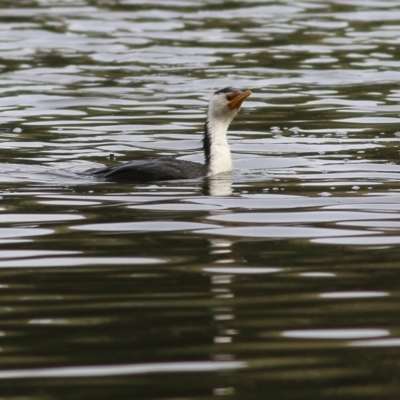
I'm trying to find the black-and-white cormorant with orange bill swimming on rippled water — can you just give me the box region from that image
[85,87,251,182]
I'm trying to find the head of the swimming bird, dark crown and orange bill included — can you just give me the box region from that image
[208,87,251,122]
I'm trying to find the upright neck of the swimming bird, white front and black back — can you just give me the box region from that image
[204,116,233,175]
